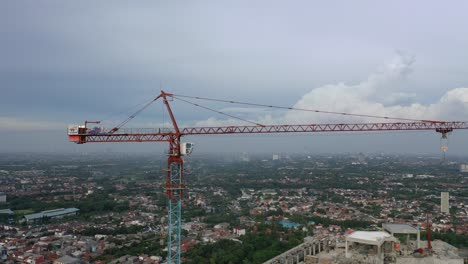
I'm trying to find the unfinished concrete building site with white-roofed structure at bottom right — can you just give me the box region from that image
[265,224,464,264]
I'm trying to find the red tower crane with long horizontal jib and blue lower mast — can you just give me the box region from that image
[68,91,468,263]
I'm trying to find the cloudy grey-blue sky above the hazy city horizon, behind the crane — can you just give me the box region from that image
[0,0,468,154]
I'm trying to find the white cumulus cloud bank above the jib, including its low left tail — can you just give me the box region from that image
[177,53,468,126]
